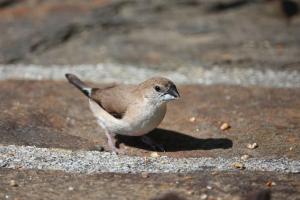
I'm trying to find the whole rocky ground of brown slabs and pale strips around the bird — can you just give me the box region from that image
[0,0,300,200]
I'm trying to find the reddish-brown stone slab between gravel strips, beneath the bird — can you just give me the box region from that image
[0,81,300,160]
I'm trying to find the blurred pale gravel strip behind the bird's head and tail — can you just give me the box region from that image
[0,63,300,88]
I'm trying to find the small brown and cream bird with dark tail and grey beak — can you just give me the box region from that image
[65,73,180,153]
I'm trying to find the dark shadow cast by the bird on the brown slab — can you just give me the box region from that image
[117,128,232,152]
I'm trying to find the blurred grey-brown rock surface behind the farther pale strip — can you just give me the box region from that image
[0,0,300,70]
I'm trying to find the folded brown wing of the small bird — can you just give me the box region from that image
[91,85,134,119]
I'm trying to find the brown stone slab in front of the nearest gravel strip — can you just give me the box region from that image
[0,169,300,200]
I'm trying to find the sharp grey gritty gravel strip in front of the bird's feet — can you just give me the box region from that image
[0,145,300,174]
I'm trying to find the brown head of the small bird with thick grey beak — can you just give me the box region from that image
[139,77,180,104]
